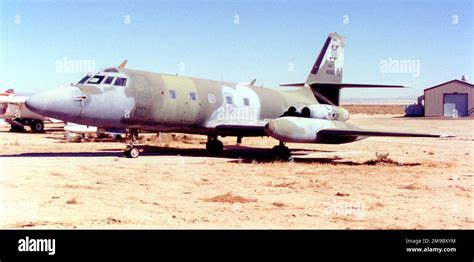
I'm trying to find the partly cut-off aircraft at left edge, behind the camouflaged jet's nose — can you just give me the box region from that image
[0,89,50,133]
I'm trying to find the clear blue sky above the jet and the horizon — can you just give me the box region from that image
[0,0,474,97]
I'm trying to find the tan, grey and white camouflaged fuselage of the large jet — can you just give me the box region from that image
[24,69,318,135]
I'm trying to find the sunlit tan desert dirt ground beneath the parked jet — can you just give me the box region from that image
[0,114,474,229]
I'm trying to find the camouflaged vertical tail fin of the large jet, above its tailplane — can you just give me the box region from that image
[305,33,344,85]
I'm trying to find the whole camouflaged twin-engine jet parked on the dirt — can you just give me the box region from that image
[26,33,452,158]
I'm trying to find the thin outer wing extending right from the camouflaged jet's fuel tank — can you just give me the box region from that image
[318,128,454,138]
